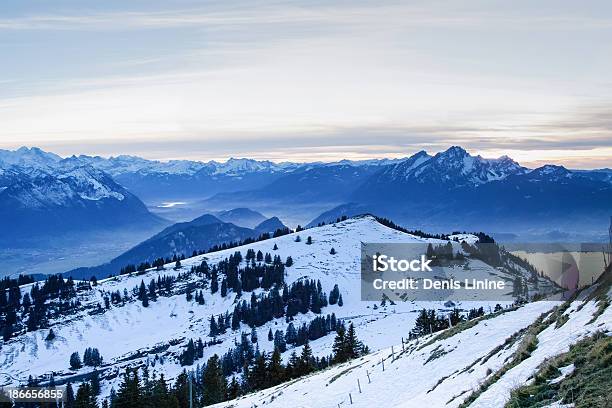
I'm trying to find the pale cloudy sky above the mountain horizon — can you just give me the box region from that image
[0,0,612,168]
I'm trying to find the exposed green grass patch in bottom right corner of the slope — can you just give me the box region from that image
[506,332,612,408]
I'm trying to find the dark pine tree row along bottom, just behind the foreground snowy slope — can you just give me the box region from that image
[57,324,368,408]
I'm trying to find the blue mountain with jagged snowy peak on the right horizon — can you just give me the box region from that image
[310,147,612,235]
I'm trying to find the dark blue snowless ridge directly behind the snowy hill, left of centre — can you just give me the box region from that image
[66,212,286,279]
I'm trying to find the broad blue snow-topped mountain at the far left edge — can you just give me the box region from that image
[0,148,165,243]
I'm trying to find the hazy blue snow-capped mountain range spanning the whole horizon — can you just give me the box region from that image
[0,146,612,252]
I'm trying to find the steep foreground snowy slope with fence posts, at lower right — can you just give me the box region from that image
[208,301,612,408]
